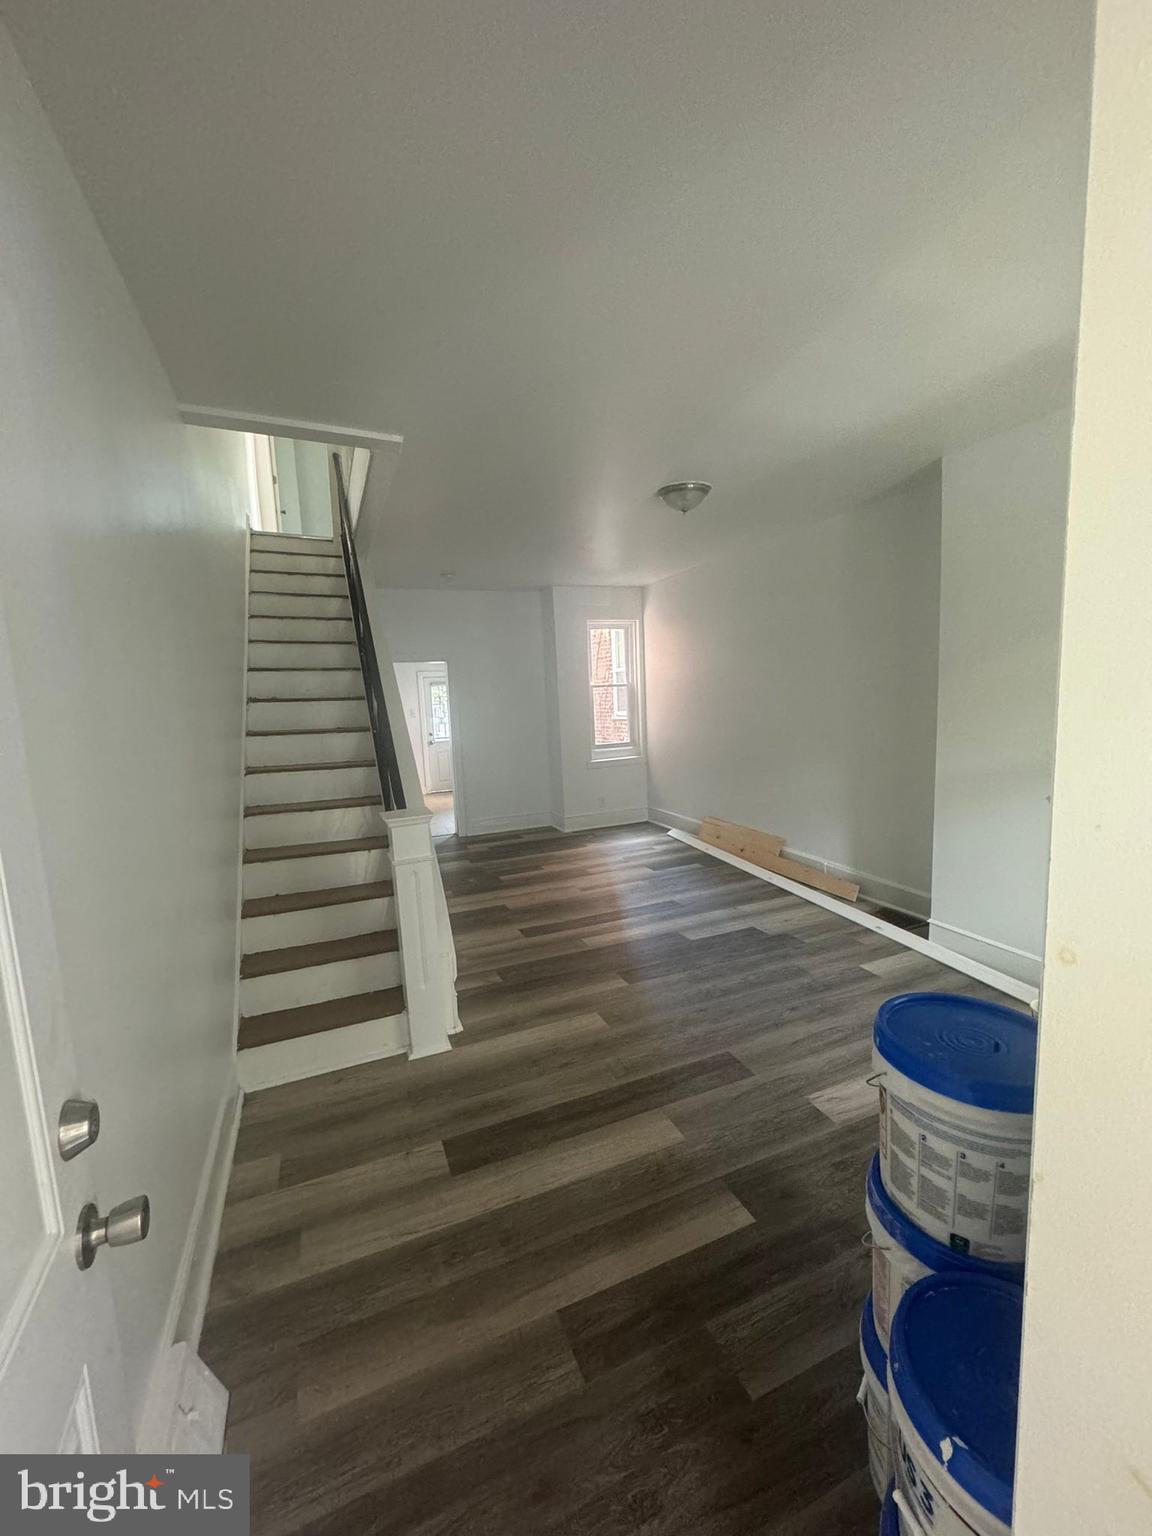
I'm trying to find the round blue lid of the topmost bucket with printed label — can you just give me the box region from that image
[872,992,1037,1115]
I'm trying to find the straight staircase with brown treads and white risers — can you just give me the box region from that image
[238,533,411,1091]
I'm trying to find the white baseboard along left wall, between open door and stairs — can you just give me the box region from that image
[137,1084,244,1452]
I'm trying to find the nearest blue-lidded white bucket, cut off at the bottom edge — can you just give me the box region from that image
[888,1273,1023,1536]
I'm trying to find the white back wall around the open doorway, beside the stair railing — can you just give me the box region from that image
[364,586,551,837]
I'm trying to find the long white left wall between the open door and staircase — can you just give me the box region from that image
[0,28,247,1448]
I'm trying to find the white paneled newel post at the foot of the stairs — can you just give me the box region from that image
[382,805,459,1060]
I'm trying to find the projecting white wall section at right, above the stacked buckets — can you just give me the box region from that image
[932,412,1071,983]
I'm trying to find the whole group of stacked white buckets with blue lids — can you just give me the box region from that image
[860,992,1037,1536]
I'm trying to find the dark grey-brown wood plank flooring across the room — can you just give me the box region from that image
[201,826,1019,1536]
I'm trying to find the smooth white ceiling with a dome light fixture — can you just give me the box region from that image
[0,0,1092,587]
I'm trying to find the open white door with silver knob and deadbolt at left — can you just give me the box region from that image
[0,622,134,1453]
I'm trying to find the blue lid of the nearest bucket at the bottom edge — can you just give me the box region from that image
[889,1273,1025,1525]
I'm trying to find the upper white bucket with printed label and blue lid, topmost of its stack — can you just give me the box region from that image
[872,992,1037,1264]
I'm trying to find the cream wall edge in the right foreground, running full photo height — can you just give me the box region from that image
[1012,0,1152,1536]
